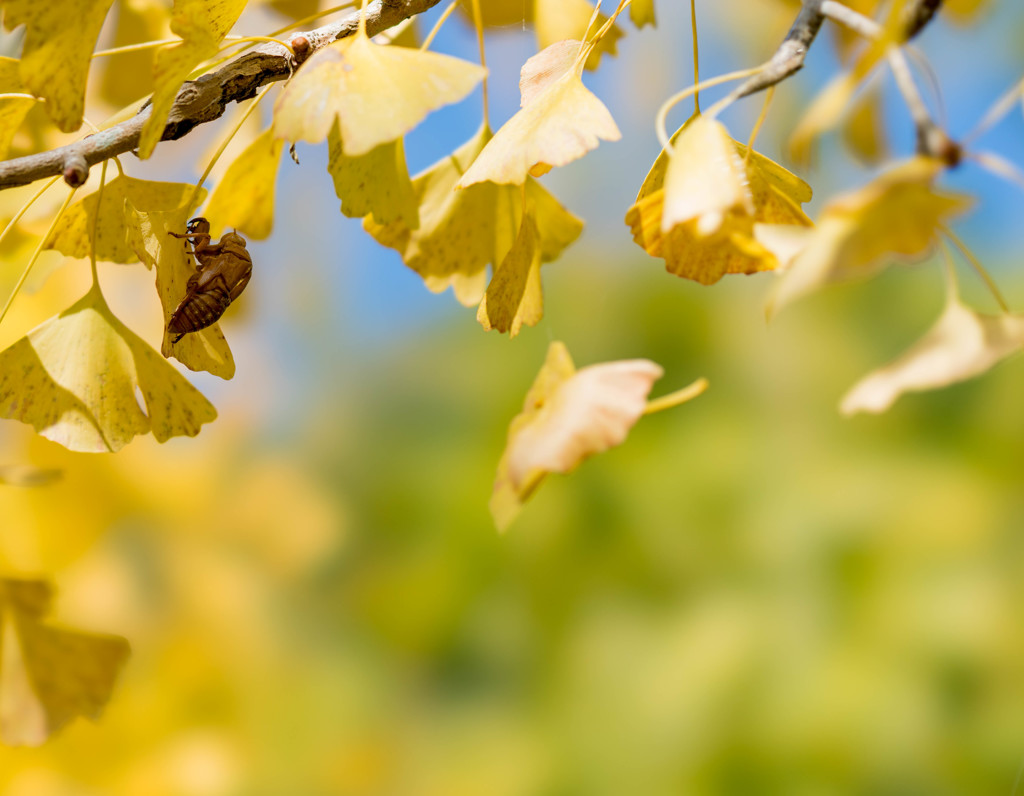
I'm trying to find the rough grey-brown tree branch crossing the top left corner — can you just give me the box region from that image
[0,0,440,191]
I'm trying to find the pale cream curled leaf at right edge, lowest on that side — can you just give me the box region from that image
[840,295,1024,415]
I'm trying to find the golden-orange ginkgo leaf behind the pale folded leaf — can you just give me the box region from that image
[626,123,811,285]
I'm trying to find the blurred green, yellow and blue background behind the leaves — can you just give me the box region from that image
[0,0,1024,796]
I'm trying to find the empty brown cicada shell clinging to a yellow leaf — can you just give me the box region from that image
[167,217,253,343]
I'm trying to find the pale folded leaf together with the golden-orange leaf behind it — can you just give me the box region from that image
[626,116,811,285]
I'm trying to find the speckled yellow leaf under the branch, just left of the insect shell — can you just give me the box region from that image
[45,176,197,263]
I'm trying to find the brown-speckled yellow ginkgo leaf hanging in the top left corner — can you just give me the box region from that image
[2,0,114,132]
